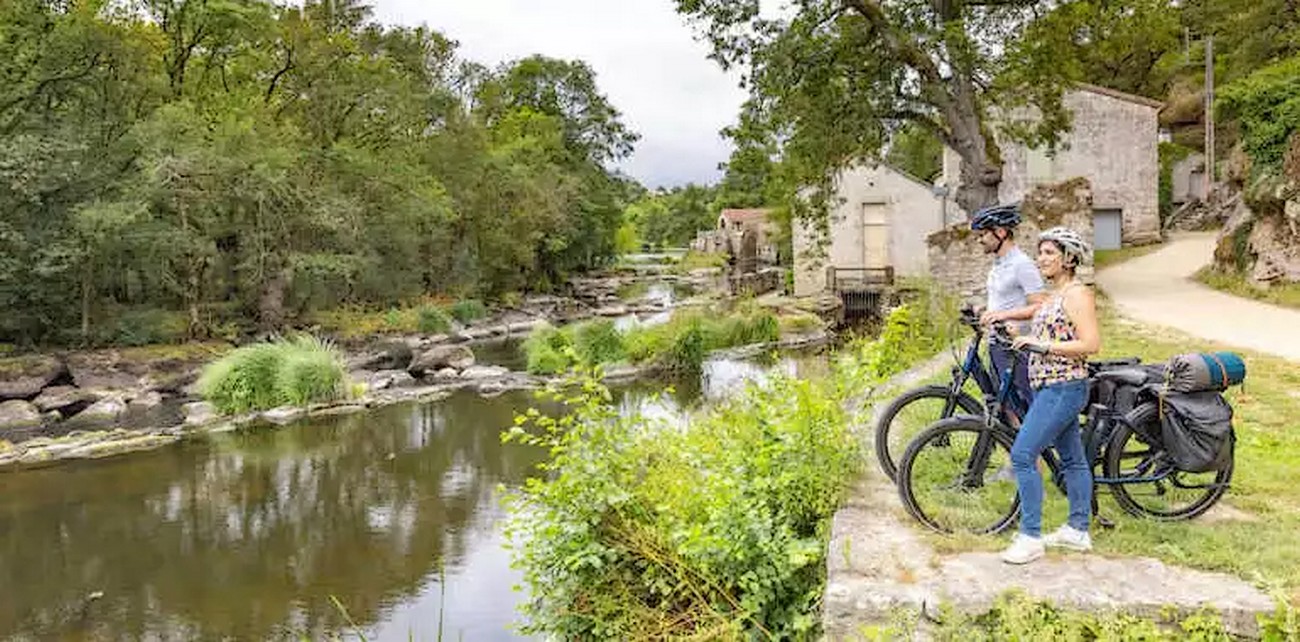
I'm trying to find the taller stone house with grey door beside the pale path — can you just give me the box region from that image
[943,83,1162,250]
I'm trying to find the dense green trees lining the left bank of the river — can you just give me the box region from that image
[0,0,640,343]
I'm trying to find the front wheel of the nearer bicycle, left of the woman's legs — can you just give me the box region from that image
[898,417,1021,534]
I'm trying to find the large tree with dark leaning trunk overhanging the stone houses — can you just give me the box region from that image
[676,0,1069,212]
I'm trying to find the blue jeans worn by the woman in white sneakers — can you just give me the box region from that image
[1011,379,1092,537]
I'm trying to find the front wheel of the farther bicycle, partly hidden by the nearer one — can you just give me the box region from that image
[876,386,984,481]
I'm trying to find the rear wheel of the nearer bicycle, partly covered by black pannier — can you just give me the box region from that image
[1104,403,1232,521]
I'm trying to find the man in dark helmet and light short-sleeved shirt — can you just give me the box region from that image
[971,204,1047,403]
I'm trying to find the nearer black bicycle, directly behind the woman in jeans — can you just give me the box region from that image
[897,323,1232,534]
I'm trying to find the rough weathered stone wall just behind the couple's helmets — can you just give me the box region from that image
[926,178,1093,305]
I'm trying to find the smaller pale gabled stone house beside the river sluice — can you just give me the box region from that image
[792,164,966,296]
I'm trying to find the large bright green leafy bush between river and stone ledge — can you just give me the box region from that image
[506,369,861,639]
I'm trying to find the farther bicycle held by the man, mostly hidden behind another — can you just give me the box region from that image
[875,307,1140,481]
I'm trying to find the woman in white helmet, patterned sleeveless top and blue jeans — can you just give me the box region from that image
[1002,227,1101,564]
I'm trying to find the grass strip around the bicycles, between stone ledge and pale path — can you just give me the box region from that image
[899,302,1300,604]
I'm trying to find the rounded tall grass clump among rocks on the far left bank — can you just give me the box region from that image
[198,335,347,413]
